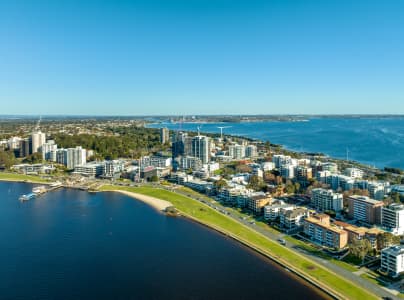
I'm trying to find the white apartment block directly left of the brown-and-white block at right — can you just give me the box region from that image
[311,188,343,212]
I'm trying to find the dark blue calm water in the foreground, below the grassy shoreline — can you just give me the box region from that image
[0,182,325,299]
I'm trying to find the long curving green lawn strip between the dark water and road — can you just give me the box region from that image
[100,186,377,299]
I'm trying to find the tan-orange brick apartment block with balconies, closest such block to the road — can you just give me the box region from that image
[303,214,348,249]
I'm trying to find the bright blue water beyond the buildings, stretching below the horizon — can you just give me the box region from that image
[153,118,404,168]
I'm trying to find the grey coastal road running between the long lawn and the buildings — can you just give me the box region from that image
[170,187,399,299]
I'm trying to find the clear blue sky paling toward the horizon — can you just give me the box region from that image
[0,0,404,115]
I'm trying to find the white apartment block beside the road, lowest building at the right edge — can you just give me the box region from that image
[380,245,404,277]
